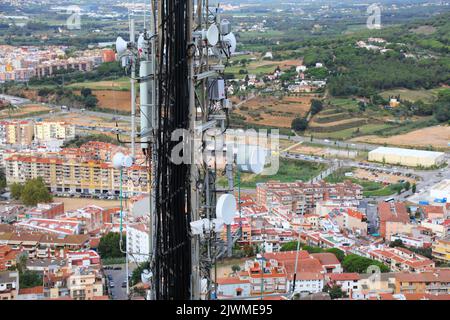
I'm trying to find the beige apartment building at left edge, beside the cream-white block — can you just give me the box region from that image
[0,120,34,146]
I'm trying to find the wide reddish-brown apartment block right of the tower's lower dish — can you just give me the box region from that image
[256,181,362,214]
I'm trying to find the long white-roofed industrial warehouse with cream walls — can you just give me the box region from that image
[369,147,445,167]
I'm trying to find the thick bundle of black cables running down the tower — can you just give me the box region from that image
[153,0,191,300]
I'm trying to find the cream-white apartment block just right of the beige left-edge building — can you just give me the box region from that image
[34,121,75,143]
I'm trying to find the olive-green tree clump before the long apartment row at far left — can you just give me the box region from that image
[10,177,53,206]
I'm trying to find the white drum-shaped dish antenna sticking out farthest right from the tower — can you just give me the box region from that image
[237,144,267,174]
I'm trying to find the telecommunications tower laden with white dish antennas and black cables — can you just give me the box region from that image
[116,0,264,300]
